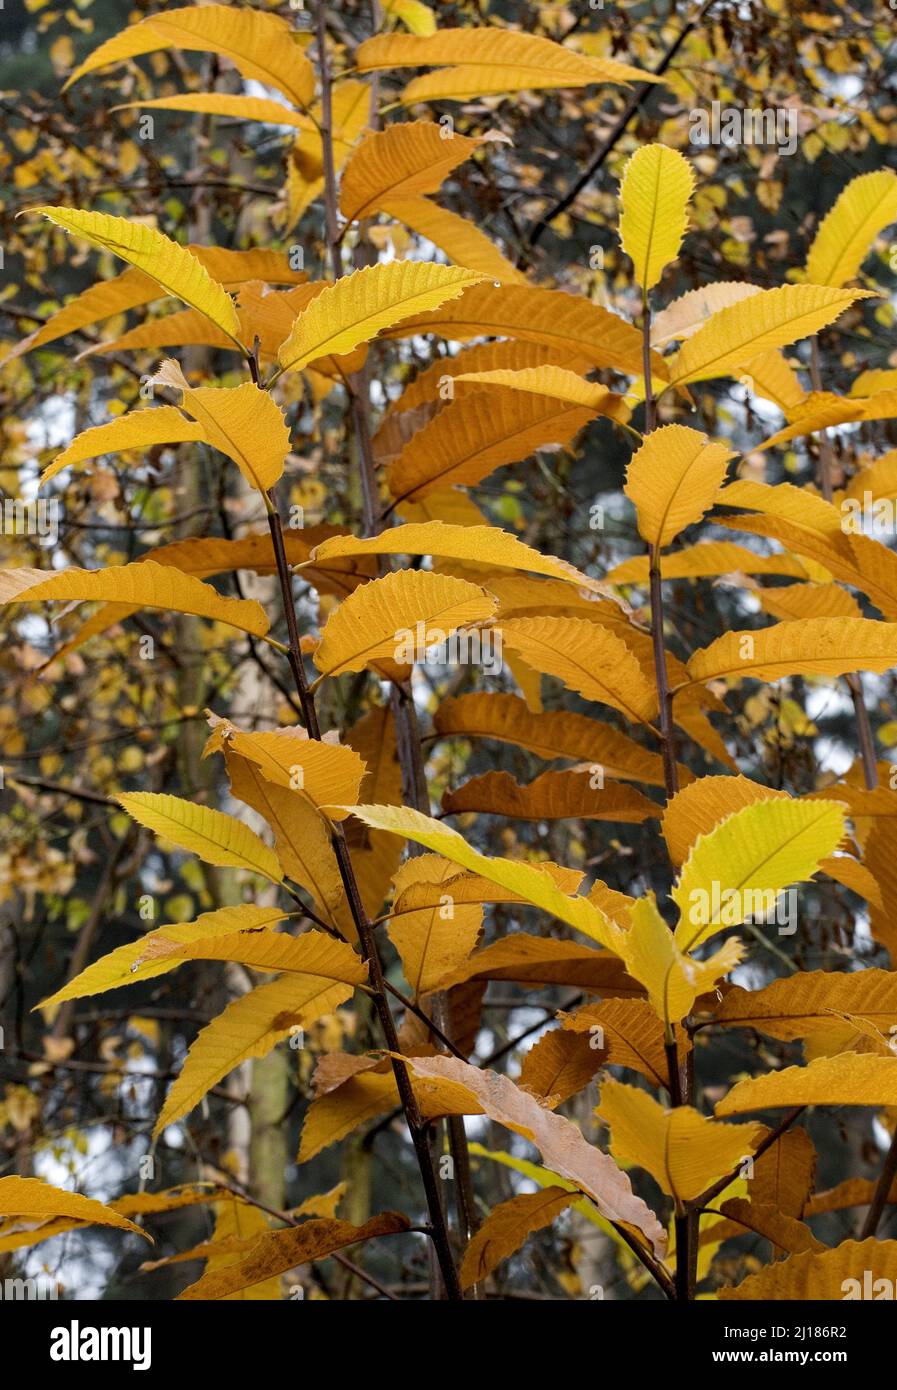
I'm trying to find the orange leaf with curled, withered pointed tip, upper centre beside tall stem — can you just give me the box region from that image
[339,121,491,222]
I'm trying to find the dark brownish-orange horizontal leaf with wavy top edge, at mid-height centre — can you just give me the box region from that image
[442,763,661,826]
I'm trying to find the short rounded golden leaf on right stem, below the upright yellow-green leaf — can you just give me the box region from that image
[623,425,733,549]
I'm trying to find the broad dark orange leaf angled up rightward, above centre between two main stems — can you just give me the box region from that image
[387,391,592,502]
